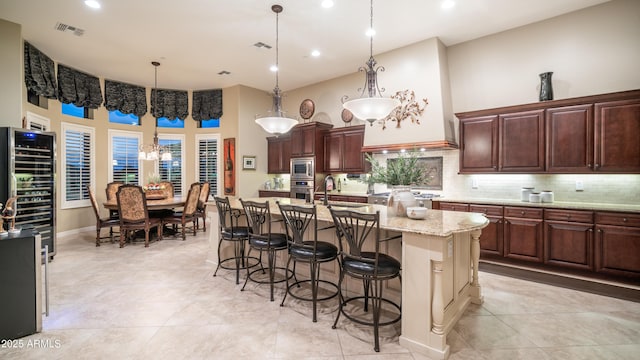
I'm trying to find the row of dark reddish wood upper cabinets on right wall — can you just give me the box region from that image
[456,90,640,173]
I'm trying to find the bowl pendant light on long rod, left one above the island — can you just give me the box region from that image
[256,5,298,136]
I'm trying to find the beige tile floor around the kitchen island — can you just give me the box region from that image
[0,228,640,360]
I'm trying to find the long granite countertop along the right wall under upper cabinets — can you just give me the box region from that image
[434,197,640,213]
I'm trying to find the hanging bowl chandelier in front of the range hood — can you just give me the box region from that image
[342,0,400,126]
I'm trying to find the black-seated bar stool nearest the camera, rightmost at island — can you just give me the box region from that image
[329,207,401,352]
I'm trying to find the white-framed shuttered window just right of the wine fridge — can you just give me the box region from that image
[60,122,95,209]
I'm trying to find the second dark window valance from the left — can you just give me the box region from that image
[58,64,102,109]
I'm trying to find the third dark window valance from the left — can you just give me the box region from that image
[104,79,147,117]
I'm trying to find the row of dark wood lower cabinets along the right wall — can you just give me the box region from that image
[433,201,640,283]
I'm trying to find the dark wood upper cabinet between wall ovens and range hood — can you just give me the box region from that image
[324,125,369,174]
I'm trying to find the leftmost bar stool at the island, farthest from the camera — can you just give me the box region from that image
[213,196,260,284]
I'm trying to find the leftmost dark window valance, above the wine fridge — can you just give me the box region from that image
[24,41,58,99]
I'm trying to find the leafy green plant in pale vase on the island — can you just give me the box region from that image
[365,151,429,216]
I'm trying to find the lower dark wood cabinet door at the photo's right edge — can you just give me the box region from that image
[595,225,640,280]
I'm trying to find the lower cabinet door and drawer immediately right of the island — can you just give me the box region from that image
[469,204,504,257]
